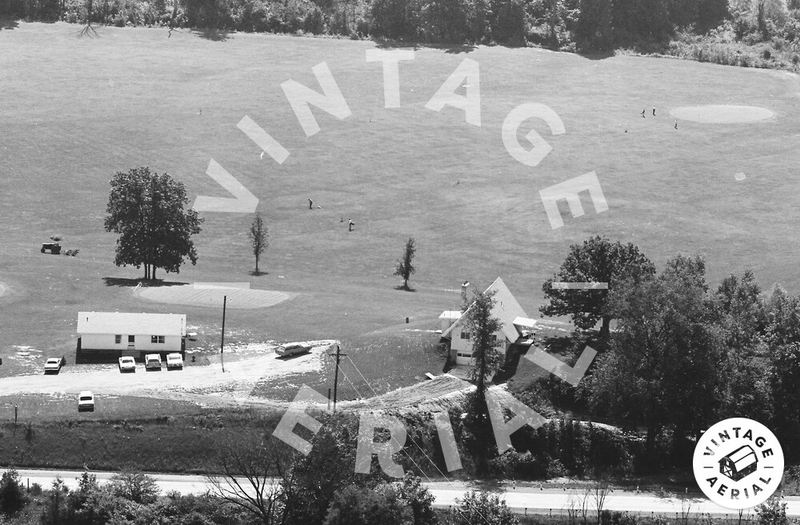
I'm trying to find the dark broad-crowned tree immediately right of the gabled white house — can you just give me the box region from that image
[540,236,655,337]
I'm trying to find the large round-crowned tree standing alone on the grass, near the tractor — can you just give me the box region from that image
[105,167,203,279]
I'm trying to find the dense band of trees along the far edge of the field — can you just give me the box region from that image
[0,0,800,67]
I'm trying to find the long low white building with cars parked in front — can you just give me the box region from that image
[77,312,186,356]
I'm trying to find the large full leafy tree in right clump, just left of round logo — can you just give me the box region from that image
[591,256,723,460]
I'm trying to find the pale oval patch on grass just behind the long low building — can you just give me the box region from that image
[138,284,291,309]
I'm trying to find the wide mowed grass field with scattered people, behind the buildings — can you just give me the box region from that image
[0,23,800,386]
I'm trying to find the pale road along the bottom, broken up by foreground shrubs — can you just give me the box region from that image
[9,469,800,517]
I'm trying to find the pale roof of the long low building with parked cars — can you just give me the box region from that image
[77,312,186,336]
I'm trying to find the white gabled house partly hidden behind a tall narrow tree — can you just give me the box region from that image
[439,277,536,366]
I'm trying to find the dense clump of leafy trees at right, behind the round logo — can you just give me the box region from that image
[518,238,800,471]
